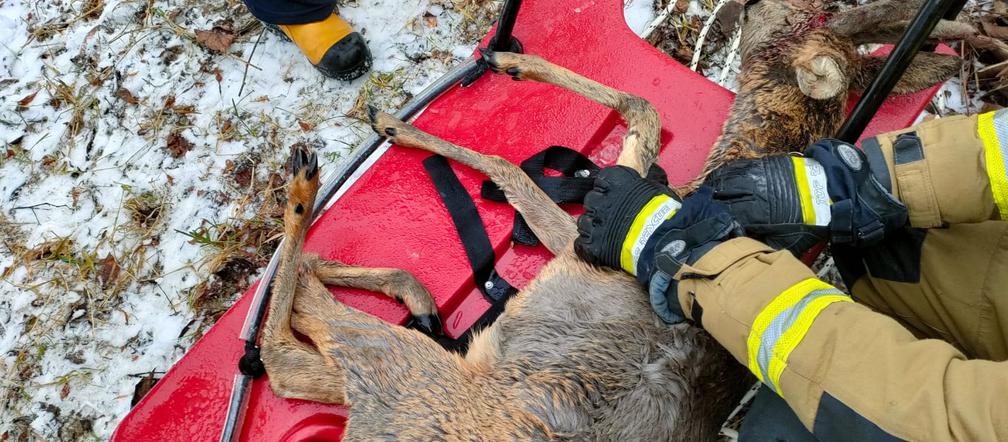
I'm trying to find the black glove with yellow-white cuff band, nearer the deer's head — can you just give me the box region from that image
[707,139,907,255]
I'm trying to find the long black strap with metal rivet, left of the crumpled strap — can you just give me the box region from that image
[423,155,518,351]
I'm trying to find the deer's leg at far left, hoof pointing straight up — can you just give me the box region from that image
[262,145,346,404]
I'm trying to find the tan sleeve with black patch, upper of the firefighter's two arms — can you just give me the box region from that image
[861,111,1008,228]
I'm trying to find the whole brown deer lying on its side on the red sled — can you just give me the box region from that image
[262,0,973,440]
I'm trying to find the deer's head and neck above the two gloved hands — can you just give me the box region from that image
[689,0,977,191]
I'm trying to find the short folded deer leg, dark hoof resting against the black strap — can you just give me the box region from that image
[302,253,443,335]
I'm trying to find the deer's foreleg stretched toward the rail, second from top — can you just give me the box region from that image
[368,104,578,254]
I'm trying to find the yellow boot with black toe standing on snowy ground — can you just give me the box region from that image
[276,14,371,81]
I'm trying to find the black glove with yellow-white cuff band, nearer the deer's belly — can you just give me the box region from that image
[575,165,743,323]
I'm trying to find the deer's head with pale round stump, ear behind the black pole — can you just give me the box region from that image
[740,0,976,100]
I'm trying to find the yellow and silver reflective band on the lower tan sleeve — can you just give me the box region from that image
[747,278,852,395]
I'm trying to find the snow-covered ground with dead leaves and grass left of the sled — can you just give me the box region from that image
[0,0,501,440]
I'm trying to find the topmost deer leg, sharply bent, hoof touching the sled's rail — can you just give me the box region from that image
[480,48,661,176]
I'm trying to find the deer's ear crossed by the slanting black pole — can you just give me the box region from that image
[851,52,963,95]
